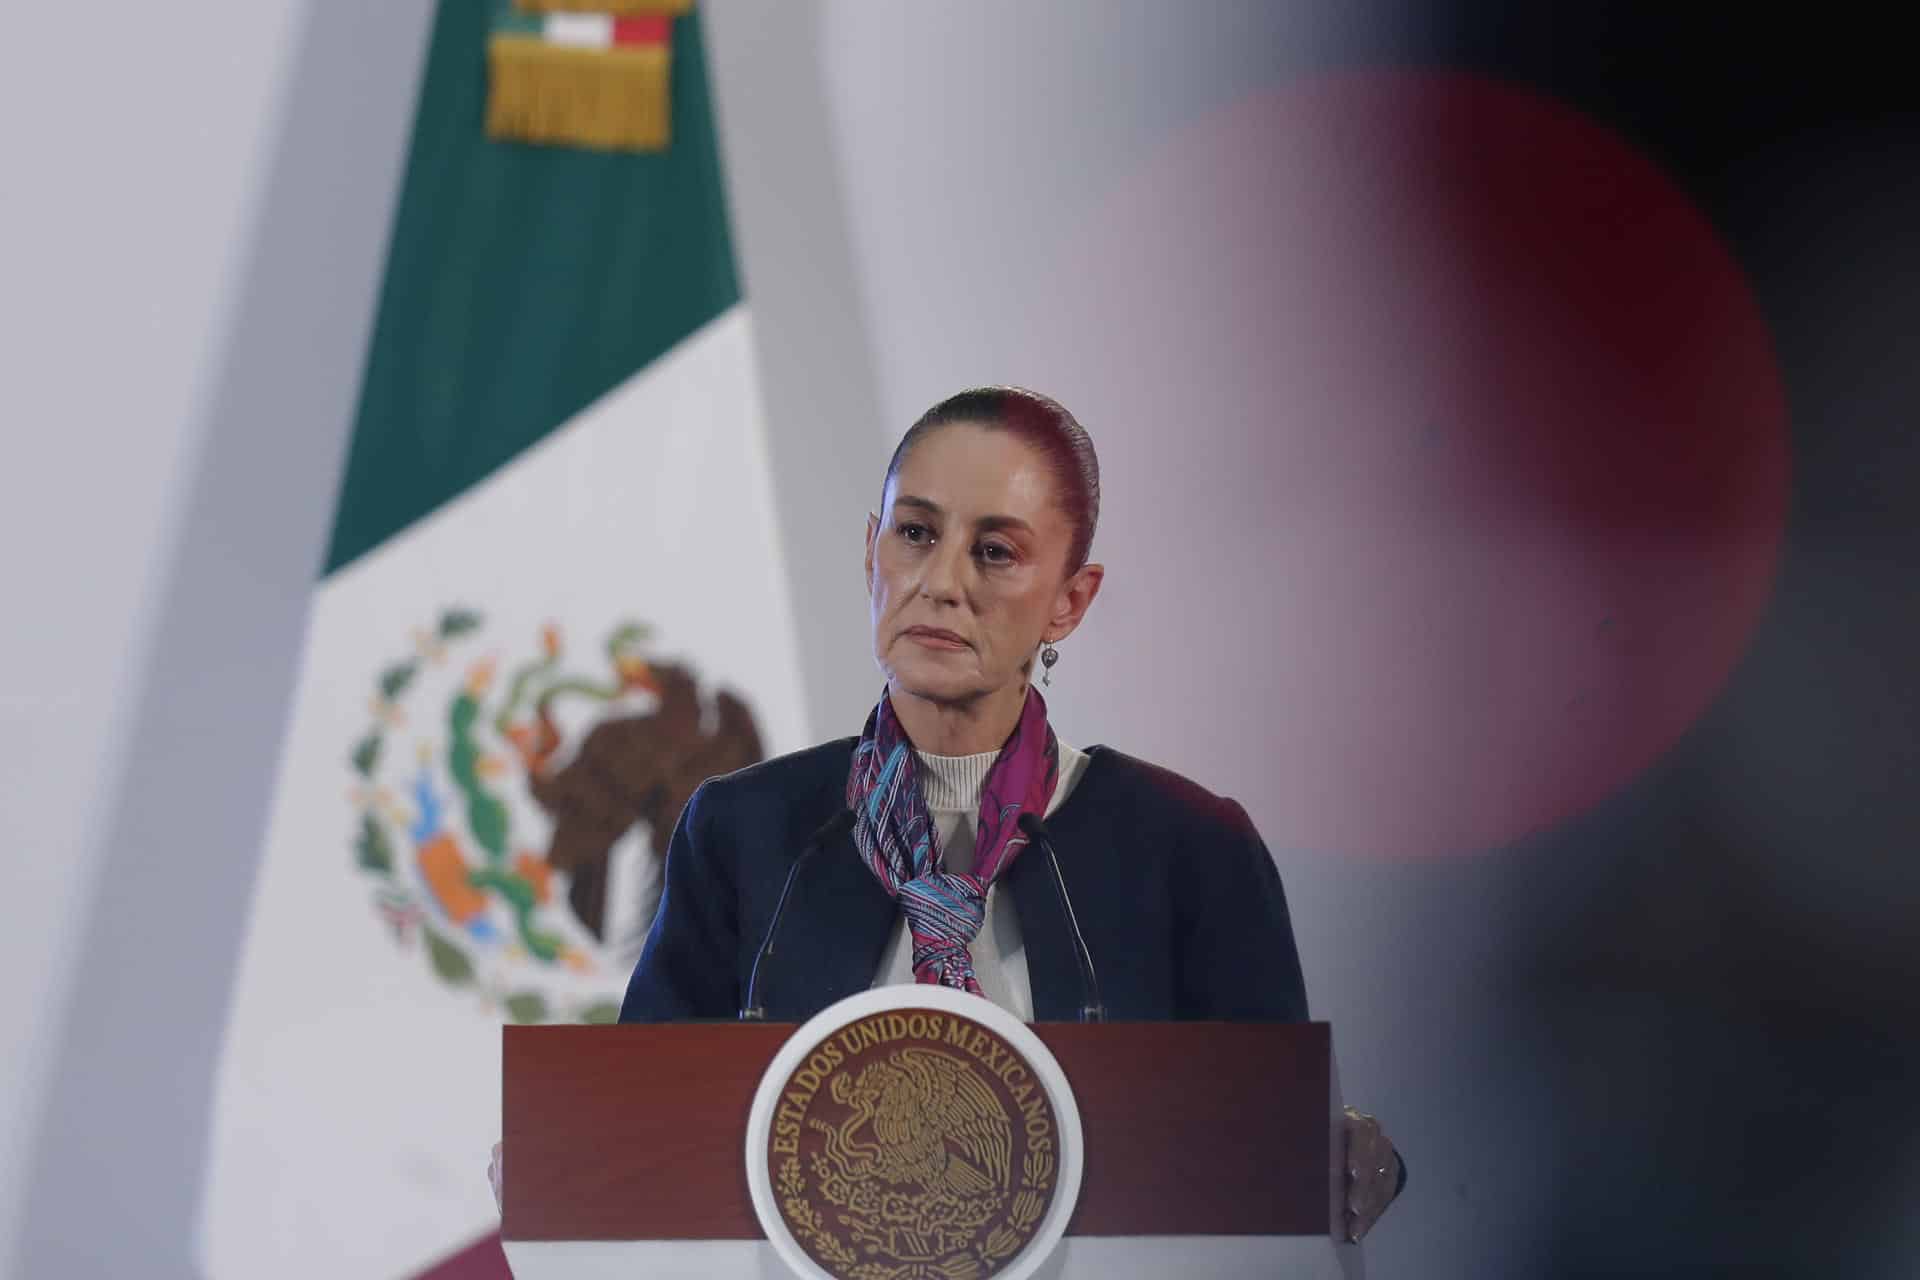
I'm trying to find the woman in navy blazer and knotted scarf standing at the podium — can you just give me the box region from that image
[620,388,1405,1240]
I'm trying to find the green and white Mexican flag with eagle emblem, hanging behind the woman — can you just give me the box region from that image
[189,0,808,1280]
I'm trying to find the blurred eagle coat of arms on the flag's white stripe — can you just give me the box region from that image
[349,608,762,1023]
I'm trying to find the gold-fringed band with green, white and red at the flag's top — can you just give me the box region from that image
[486,0,691,152]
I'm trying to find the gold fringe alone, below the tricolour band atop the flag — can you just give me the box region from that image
[486,35,672,152]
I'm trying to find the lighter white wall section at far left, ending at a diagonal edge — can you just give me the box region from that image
[0,2,311,1259]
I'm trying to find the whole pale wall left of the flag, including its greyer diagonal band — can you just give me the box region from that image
[0,0,430,1280]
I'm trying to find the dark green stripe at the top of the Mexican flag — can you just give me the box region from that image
[324,0,741,574]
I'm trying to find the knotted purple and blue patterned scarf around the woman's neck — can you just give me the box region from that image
[847,689,1060,996]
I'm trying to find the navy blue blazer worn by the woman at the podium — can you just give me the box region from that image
[620,737,1308,1023]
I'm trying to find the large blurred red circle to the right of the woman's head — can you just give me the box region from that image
[1029,71,1788,854]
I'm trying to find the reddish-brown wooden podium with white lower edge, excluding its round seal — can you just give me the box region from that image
[501,1023,1363,1280]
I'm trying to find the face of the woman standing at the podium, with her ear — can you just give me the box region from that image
[866,422,1102,717]
